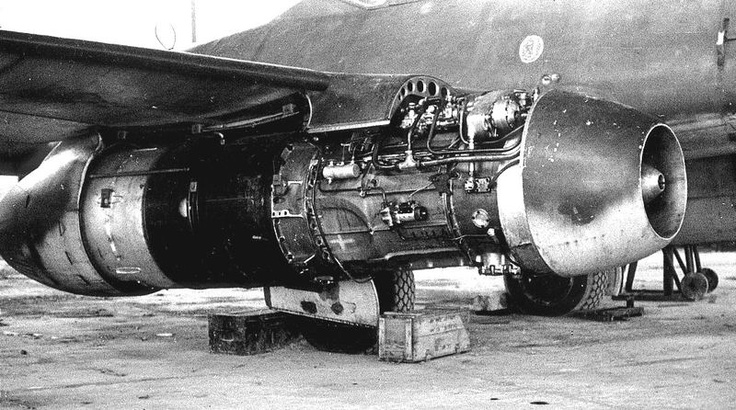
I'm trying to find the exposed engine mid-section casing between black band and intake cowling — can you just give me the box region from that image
[273,144,501,277]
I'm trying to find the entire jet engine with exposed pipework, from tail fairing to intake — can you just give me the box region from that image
[0,77,686,295]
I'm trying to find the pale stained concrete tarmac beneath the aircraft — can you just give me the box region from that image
[0,253,736,409]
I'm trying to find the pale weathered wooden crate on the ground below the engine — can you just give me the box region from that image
[378,310,470,362]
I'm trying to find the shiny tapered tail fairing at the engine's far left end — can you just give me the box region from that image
[0,135,155,296]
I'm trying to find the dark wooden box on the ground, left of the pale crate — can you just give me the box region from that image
[209,309,299,355]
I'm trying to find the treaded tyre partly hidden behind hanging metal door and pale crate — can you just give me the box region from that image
[300,267,415,354]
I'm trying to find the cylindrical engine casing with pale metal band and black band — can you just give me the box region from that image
[82,141,296,288]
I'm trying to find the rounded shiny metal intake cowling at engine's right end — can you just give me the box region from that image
[498,90,687,276]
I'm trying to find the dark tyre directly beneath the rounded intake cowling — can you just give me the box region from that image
[504,271,611,316]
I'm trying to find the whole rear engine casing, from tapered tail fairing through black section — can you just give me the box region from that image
[0,137,288,296]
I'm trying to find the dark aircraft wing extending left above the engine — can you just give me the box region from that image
[0,31,414,155]
